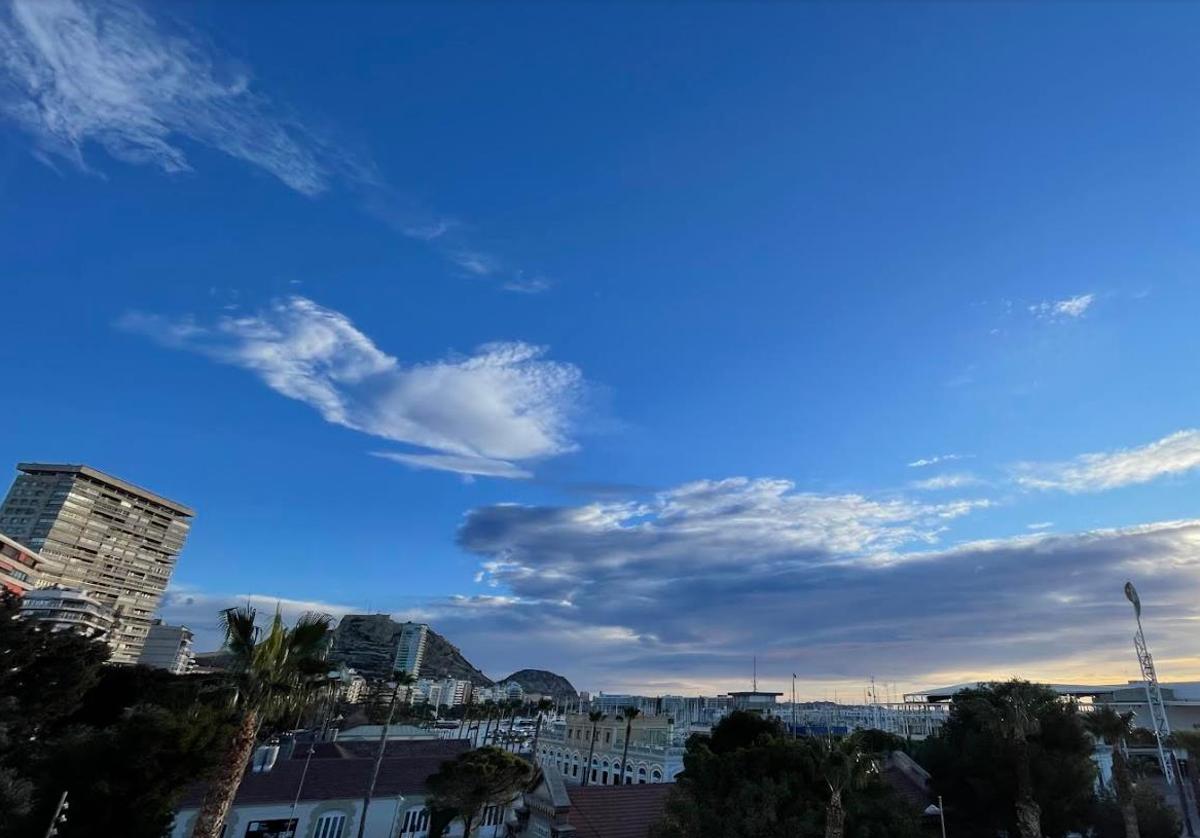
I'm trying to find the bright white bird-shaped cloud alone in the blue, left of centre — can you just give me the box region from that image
[120,297,584,477]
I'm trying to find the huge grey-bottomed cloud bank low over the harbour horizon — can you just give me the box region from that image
[453,478,1200,688]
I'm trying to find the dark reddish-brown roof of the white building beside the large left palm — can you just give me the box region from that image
[180,740,470,809]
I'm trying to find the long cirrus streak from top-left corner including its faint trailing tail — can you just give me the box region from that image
[0,0,550,294]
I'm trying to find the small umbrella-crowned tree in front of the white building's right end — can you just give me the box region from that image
[427,747,533,838]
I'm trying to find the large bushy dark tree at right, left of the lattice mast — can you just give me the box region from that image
[917,680,1096,838]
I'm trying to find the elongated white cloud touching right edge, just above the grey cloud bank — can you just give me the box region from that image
[1014,430,1200,492]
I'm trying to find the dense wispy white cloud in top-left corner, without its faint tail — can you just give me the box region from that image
[0,0,330,194]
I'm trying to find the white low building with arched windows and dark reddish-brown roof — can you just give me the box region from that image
[170,740,506,838]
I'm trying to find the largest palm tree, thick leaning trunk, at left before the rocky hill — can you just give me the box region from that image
[192,605,332,838]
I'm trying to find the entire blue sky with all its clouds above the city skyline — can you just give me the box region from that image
[0,0,1200,695]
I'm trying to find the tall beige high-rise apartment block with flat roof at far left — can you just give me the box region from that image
[0,462,194,664]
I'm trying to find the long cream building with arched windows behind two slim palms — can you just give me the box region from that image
[538,713,684,785]
